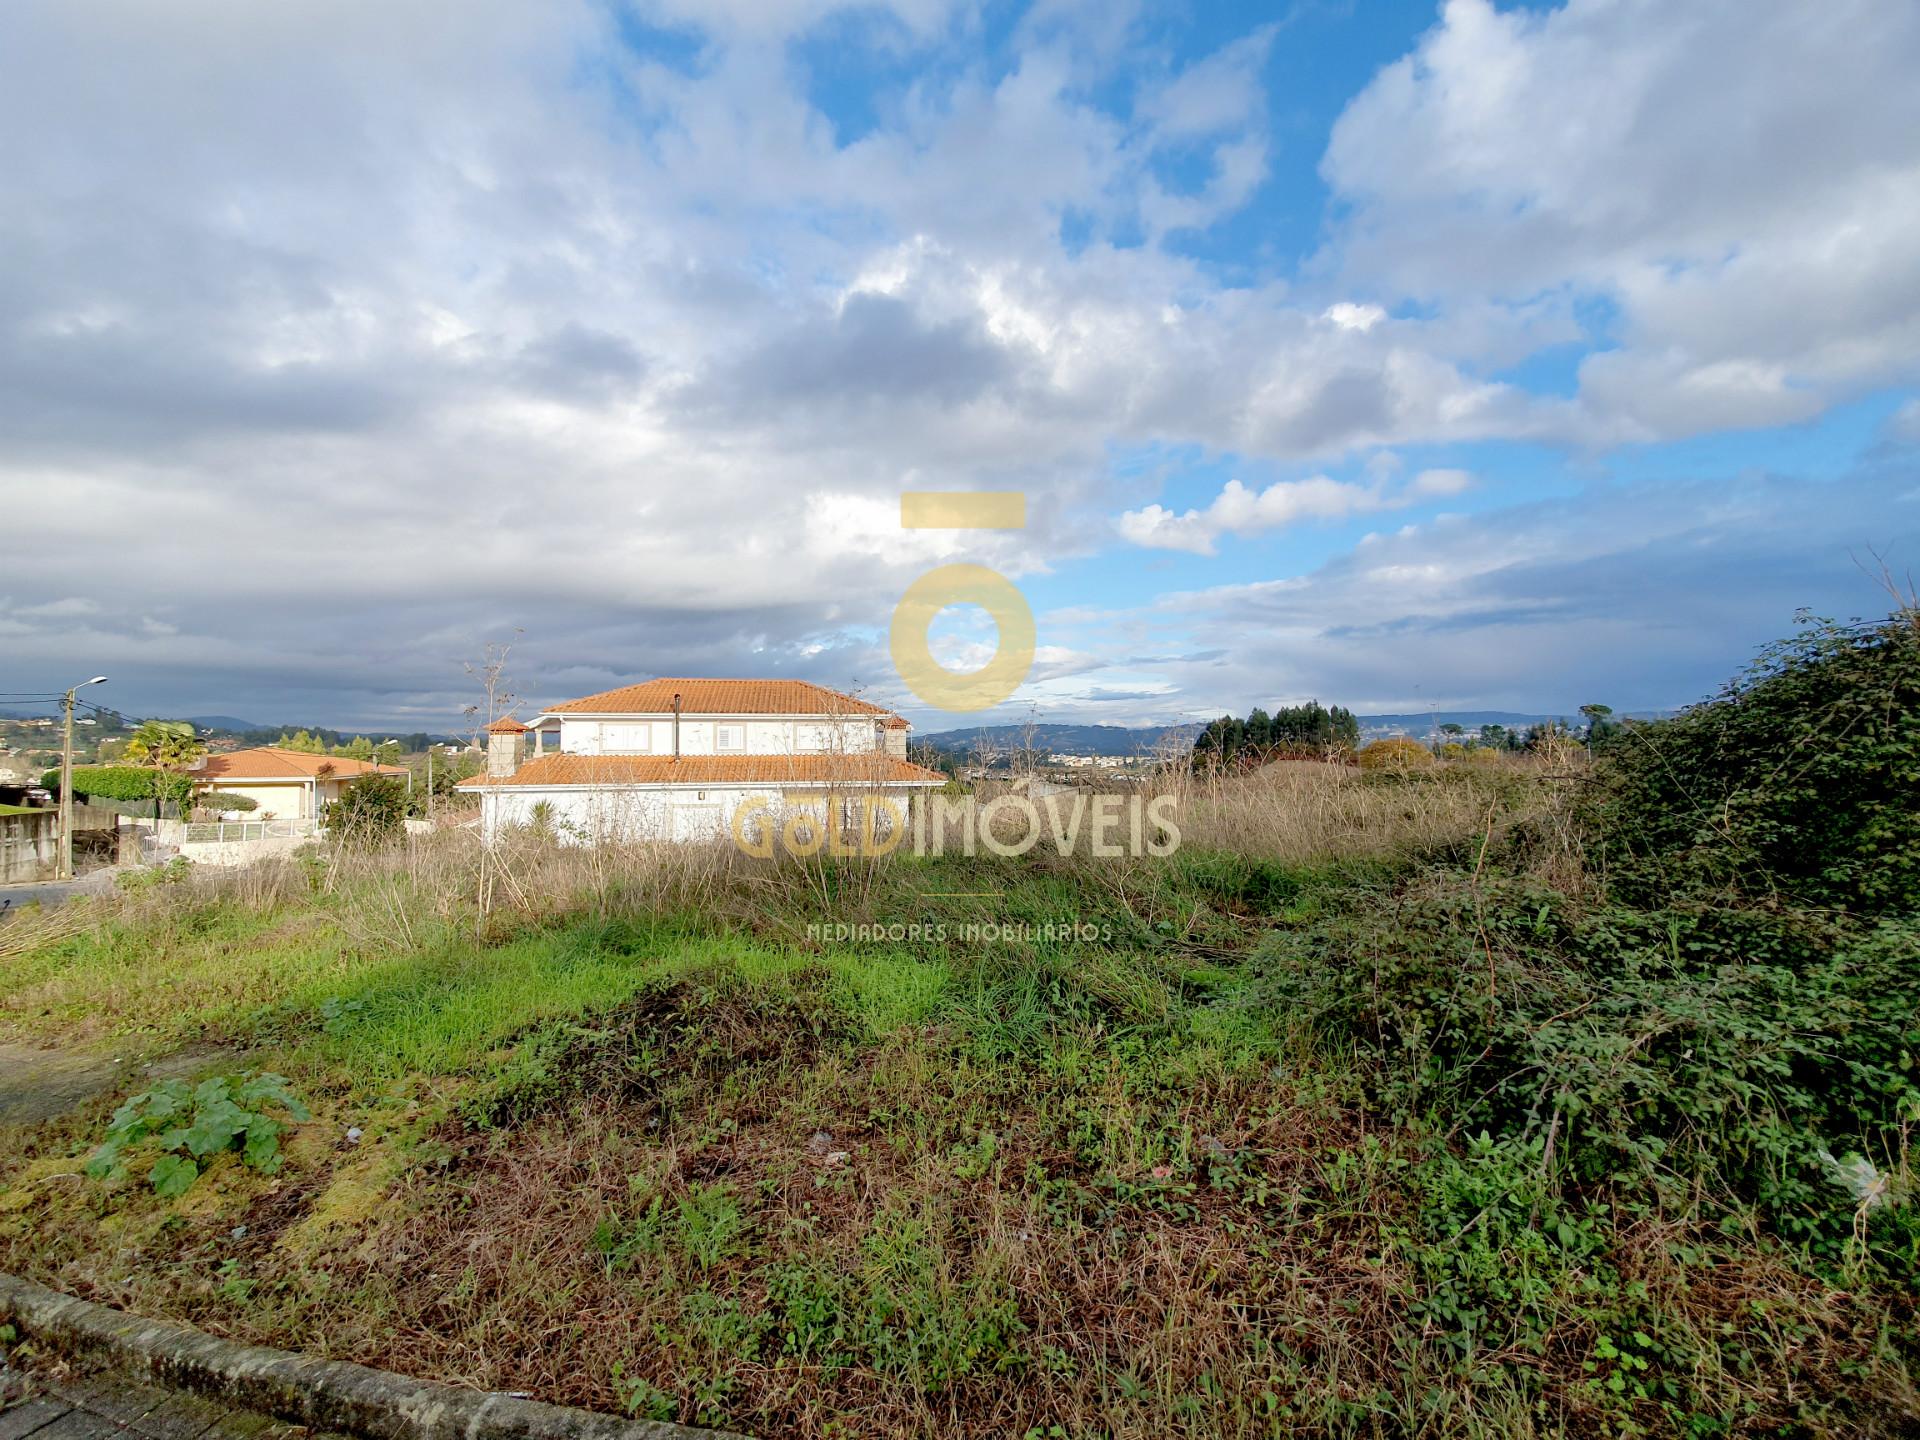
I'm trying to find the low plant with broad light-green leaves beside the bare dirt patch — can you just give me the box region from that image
[86,1073,313,1200]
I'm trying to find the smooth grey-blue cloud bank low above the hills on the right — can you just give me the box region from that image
[1046,457,1920,722]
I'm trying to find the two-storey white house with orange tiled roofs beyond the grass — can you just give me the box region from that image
[461,680,945,843]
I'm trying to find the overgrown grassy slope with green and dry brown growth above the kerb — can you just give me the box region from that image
[0,760,1914,1436]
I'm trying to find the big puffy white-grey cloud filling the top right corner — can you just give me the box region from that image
[1323,0,1920,444]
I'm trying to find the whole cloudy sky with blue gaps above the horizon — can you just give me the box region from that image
[0,0,1920,730]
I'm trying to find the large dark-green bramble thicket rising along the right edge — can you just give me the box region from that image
[1252,612,1920,1404]
